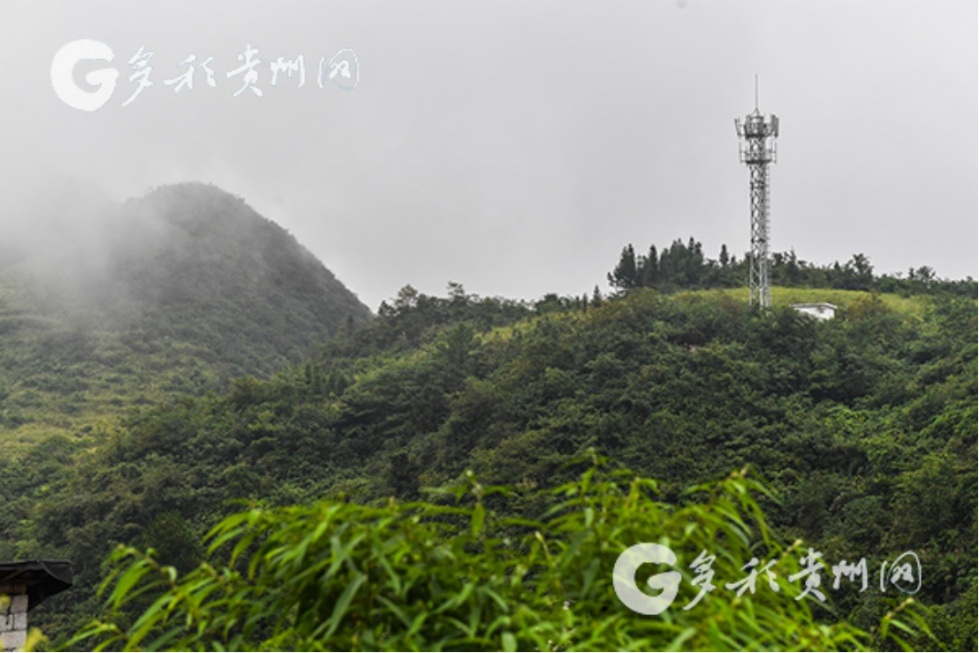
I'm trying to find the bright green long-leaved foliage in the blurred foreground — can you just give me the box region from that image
[60,460,928,653]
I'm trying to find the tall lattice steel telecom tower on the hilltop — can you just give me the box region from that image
[734,76,778,308]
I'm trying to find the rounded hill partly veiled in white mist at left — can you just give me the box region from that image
[0,184,370,452]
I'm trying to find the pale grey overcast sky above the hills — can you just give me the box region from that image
[0,0,979,310]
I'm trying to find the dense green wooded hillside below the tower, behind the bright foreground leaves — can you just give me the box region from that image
[0,276,979,651]
